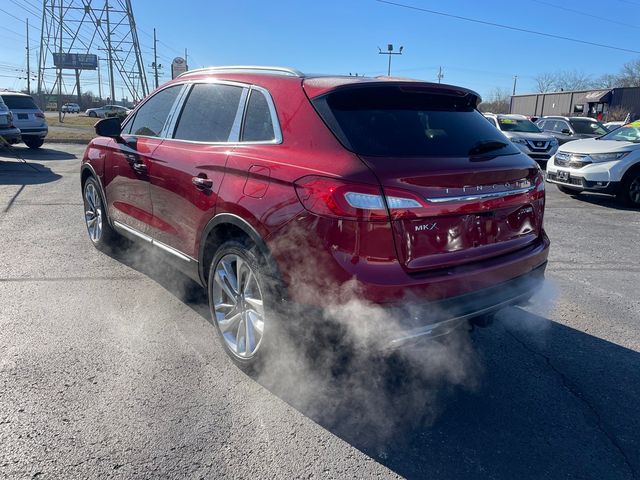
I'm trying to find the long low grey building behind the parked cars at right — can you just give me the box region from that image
[510,87,640,121]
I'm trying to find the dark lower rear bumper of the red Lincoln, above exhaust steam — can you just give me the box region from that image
[383,262,547,348]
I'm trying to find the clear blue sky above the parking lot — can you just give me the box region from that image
[0,0,640,96]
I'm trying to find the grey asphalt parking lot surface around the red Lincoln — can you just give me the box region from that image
[0,143,640,479]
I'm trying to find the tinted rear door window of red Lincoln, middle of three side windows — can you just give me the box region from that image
[174,83,242,142]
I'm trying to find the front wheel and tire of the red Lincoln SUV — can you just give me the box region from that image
[82,177,120,251]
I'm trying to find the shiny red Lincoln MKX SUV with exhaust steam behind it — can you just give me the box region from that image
[81,67,549,366]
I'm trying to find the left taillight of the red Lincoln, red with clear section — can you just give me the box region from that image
[295,176,427,221]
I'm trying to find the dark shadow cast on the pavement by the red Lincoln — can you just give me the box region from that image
[100,246,640,480]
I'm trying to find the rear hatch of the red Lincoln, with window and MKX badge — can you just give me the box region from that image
[313,82,544,272]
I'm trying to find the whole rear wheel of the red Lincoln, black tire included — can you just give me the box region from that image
[208,239,279,372]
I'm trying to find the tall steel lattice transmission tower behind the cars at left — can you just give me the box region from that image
[38,0,149,111]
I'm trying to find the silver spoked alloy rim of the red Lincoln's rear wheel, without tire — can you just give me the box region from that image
[212,254,264,360]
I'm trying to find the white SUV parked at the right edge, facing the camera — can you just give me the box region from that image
[547,120,640,207]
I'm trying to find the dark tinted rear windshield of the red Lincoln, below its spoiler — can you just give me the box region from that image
[313,85,519,157]
